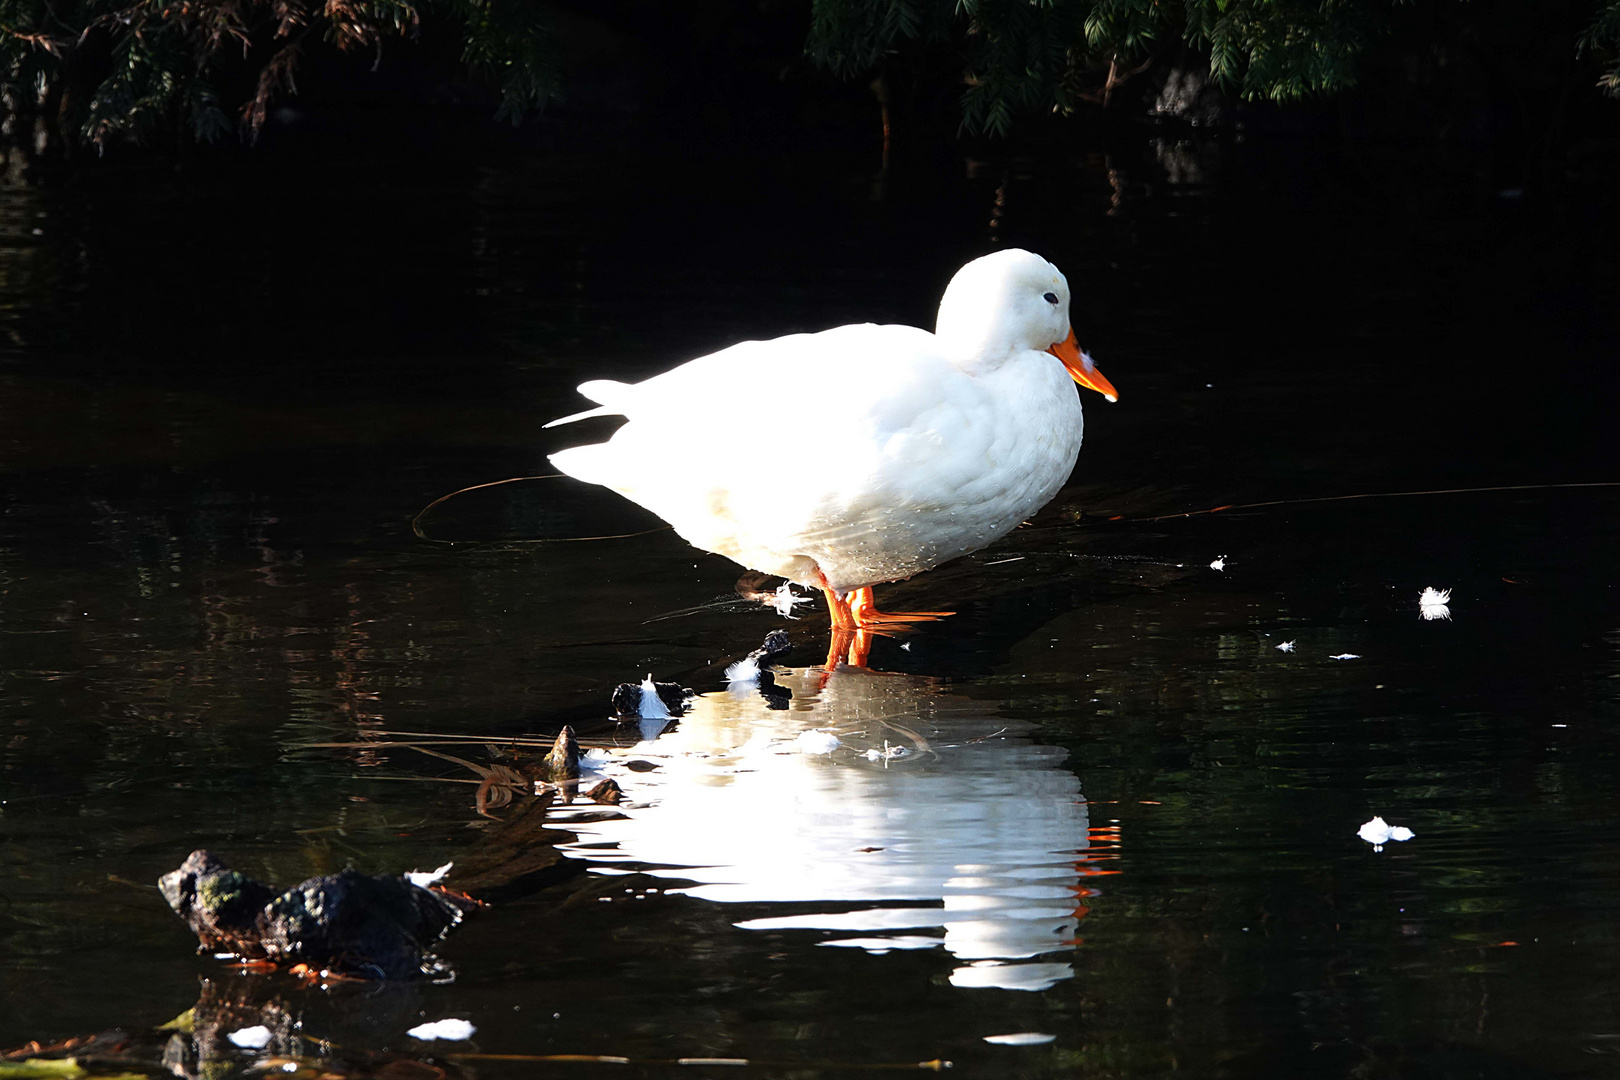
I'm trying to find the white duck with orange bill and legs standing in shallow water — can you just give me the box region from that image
[546,249,1118,630]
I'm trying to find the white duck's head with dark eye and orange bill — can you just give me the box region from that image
[933,248,1119,402]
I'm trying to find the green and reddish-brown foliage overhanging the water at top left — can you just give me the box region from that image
[0,0,556,146]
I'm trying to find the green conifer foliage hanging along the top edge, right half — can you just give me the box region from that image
[808,0,1620,134]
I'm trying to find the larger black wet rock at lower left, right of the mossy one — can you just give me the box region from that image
[258,868,470,980]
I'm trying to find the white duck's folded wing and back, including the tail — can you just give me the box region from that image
[551,324,995,573]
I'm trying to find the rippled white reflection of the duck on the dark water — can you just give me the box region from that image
[559,669,1105,989]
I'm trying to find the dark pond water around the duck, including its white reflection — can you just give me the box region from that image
[0,144,1620,1077]
